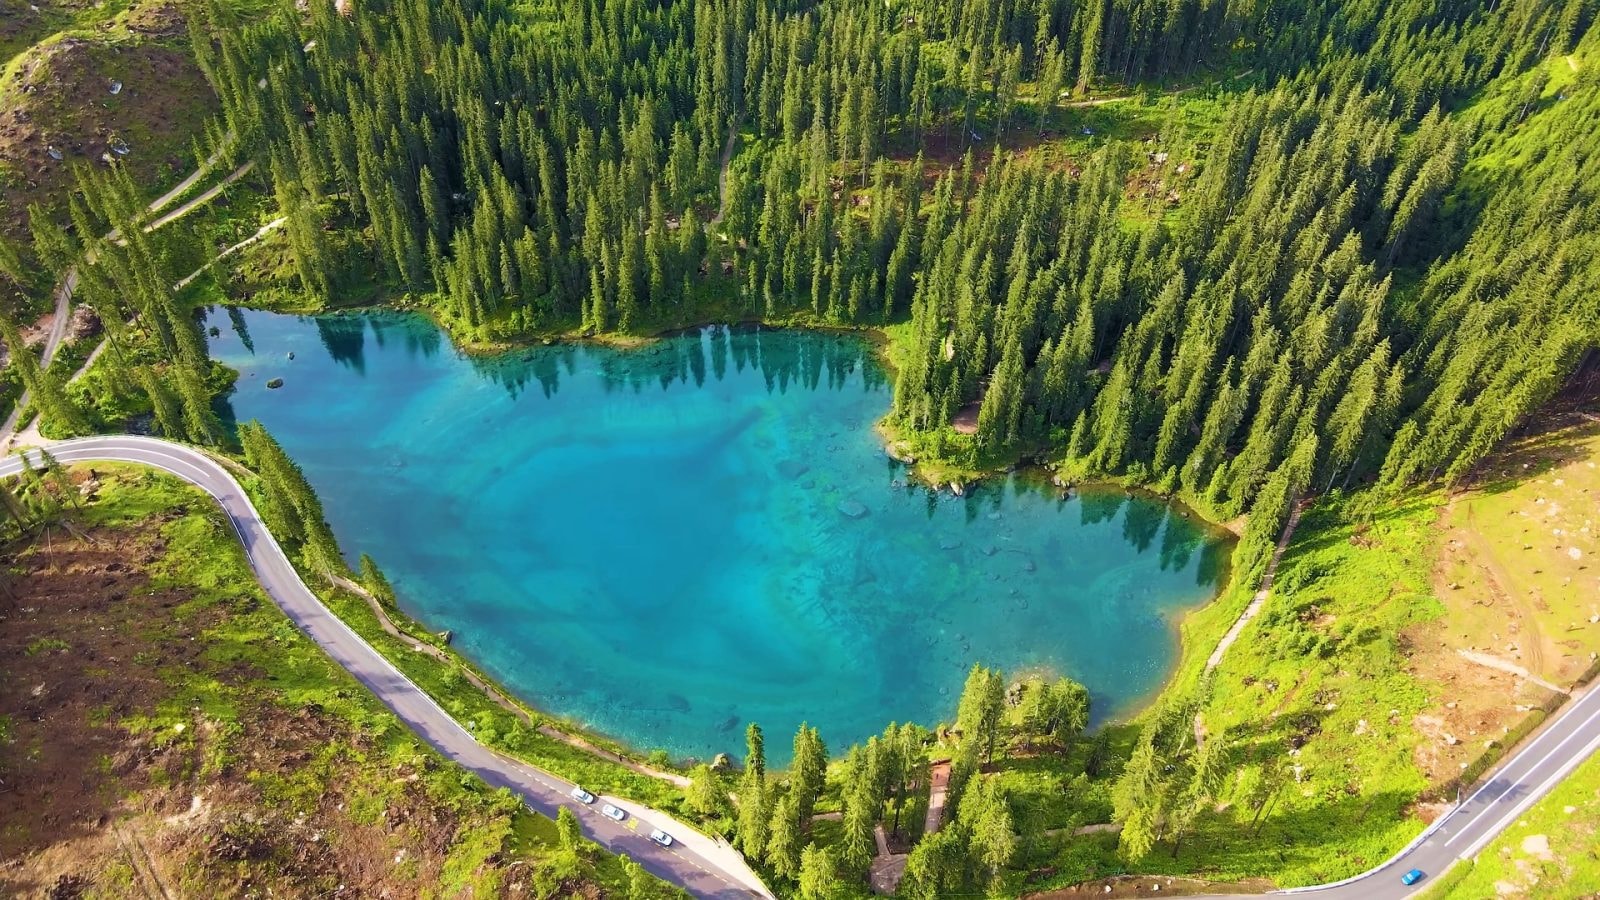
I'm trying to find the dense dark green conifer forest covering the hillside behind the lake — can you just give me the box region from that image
[144,0,1600,567]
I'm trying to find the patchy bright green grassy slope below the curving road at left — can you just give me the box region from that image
[0,466,681,897]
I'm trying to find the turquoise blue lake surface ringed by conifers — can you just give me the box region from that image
[210,311,1227,764]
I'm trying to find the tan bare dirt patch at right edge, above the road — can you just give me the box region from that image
[1401,420,1600,791]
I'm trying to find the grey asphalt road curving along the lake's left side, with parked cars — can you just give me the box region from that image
[0,436,770,900]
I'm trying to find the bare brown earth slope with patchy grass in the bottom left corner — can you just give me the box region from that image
[0,474,598,898]
